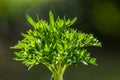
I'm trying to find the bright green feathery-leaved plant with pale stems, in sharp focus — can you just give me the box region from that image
[12,11,101,80]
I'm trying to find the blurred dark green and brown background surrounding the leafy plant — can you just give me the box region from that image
[0,0,120,80]
